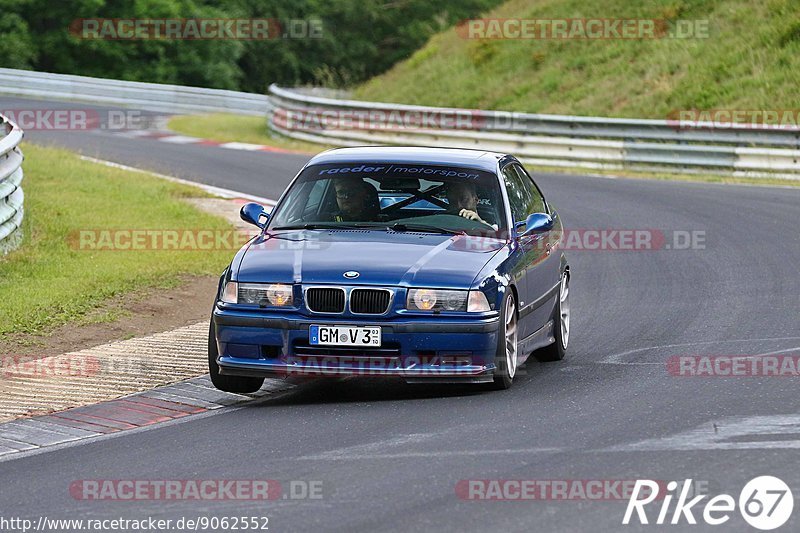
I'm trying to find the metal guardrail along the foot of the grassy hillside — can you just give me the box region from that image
[268,85,800,179]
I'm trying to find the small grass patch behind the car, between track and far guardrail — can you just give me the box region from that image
[167,113,332,154]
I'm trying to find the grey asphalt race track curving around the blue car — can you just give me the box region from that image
[0,98,800,531]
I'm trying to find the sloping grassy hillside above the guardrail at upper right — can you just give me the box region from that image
[355,0,800,118]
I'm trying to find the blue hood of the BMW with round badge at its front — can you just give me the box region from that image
[236,230,506,288]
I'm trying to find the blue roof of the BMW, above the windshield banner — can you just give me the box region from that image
[308,146,510,172]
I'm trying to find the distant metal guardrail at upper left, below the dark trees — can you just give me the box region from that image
[0,68,270,116]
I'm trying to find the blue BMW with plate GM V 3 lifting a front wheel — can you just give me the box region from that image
[208,147,570,393]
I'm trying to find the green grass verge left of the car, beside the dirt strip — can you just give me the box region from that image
[0,144,231,339]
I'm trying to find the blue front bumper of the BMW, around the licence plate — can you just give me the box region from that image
[213,307,499,383]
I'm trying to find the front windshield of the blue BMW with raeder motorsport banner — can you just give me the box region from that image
[269,163,506,234]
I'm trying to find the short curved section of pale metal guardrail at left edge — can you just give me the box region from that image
[0,115,25,255]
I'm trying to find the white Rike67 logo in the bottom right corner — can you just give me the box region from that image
[622,476,794,531]
